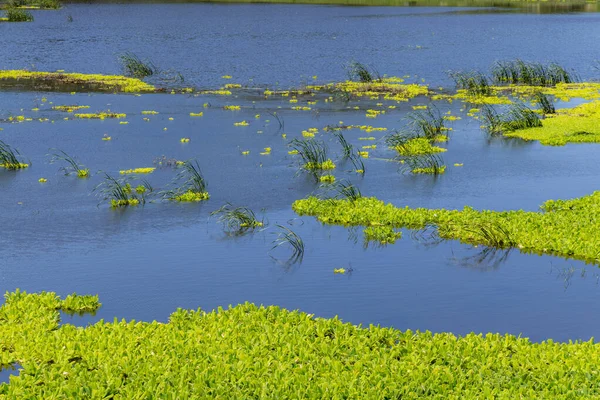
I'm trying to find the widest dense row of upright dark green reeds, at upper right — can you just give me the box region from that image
[492,59,577,86]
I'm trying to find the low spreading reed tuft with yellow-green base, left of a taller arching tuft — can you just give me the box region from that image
[94,173,153,208]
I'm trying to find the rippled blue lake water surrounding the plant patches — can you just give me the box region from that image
[0,4,600,341]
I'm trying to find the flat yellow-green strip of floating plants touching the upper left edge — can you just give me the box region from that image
[0,70,156,93]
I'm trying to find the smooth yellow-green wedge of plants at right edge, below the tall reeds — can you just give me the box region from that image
[505,101,600,146]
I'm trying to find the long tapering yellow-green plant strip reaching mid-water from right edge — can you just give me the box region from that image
[293,192,600,264]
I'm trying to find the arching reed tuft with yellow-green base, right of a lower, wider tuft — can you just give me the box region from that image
[163,161,210,202]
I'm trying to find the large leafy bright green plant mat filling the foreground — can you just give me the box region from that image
[0,290,600,399]
